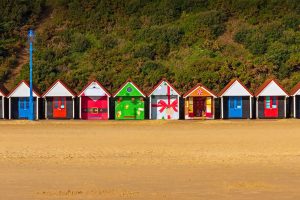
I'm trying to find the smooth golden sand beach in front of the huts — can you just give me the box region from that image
[0,119,300,200]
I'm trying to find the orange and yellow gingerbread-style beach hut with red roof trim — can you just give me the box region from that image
[183,83,217,119]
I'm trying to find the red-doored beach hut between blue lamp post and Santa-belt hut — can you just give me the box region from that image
[42,80,76,119]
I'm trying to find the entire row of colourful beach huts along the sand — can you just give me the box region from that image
[0,79,300,120]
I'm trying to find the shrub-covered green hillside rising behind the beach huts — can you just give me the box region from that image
[0,0,300,92]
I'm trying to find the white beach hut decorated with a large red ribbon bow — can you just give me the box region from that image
[148,79,180,119]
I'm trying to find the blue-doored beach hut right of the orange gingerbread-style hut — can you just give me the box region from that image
[218,79,253,119]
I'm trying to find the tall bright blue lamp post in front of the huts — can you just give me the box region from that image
[28,29,34,121]
